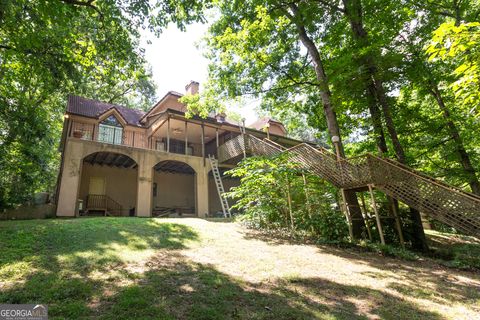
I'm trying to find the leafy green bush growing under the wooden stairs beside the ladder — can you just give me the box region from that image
[227,154,348,240]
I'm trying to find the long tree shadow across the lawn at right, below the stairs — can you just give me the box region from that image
[239,230,480,311]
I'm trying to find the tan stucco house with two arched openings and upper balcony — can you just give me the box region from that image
[57,81,301,217]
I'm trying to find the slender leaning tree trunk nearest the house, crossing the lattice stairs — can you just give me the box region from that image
[290,3,365,239]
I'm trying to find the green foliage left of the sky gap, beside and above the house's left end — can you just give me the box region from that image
[0,0,208,210]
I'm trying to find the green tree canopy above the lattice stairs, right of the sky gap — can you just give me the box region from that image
[205,0,480,205]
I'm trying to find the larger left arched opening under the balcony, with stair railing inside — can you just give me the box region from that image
[79,152,138,216]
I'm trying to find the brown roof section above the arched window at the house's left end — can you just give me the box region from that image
[67,95,145,127]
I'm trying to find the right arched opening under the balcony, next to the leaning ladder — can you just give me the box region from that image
[152,160,196,217]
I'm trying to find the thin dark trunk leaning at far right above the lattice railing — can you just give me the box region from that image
[430,83,480,195]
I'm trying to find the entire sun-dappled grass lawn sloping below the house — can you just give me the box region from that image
[0,218,480,319]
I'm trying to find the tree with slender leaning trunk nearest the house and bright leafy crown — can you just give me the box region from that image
[202,1,364,238]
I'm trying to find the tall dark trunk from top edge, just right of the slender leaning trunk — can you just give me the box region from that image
[342,0,428,251]
